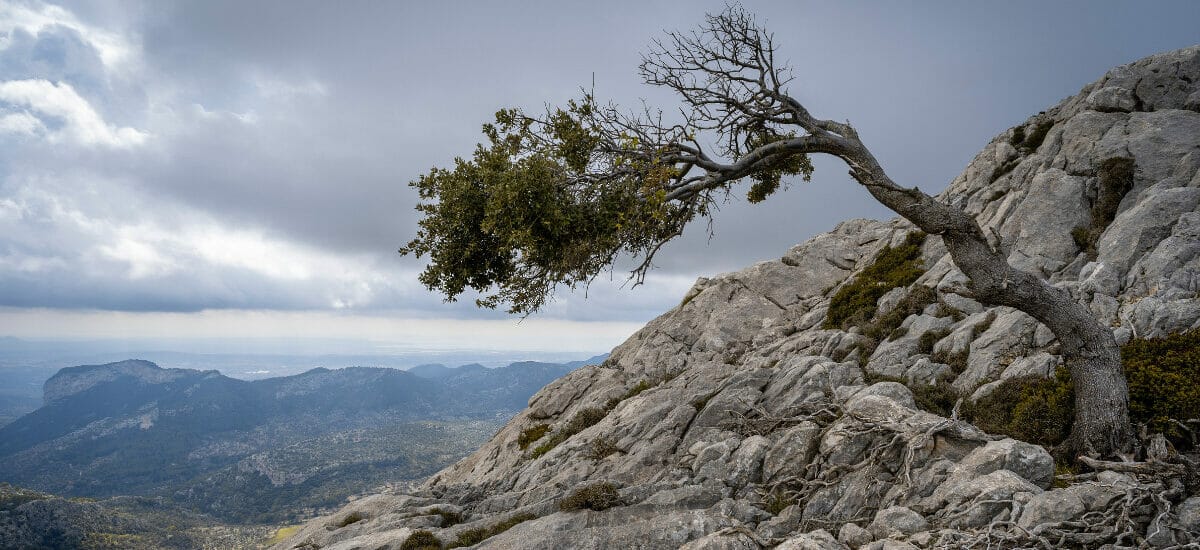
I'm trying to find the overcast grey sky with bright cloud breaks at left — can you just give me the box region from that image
[0,0,1200,351]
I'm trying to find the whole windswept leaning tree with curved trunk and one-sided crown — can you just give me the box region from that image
[401,7,1133,456]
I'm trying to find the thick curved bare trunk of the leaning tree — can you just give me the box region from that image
[839,136,1134,458]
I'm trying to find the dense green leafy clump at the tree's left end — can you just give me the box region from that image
[400,96,707,313]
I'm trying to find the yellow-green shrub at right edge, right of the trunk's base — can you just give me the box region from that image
[1121,329,1200,447]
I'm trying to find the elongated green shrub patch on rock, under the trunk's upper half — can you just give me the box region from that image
[823,232,925,329]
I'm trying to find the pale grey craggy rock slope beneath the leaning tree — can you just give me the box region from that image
[276,47,1200,549]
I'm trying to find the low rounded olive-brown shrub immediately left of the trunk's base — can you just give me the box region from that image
[961,367,1075,447]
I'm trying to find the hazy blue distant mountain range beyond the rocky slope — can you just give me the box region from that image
[0,358,602,522]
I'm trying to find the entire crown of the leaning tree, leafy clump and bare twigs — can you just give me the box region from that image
[401,8,812,313]
